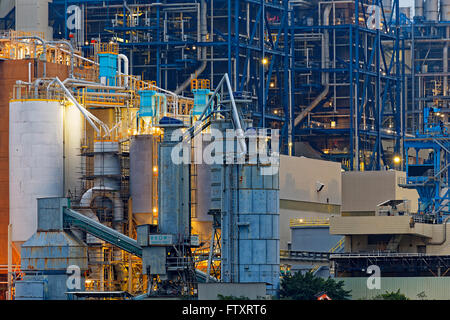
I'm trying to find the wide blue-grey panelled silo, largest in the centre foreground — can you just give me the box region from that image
[211,120,280,295]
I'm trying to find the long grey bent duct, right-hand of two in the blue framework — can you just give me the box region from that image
[294,5,331,127]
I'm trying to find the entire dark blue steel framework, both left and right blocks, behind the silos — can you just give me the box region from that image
[52,0,405,170]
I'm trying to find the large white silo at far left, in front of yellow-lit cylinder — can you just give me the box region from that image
[9,100,64,242]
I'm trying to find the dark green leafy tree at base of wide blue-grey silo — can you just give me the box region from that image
[280,272,351,300]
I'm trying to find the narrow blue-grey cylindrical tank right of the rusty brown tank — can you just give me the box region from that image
[158,124,191,242]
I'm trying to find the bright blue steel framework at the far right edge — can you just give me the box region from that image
[401,10,450,223]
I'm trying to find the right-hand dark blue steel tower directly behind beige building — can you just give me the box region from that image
[291,0,404,170]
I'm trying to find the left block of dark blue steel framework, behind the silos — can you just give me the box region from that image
[53,0,290,153]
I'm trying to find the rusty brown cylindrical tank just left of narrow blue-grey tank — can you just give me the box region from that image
[130,135,158,225]
